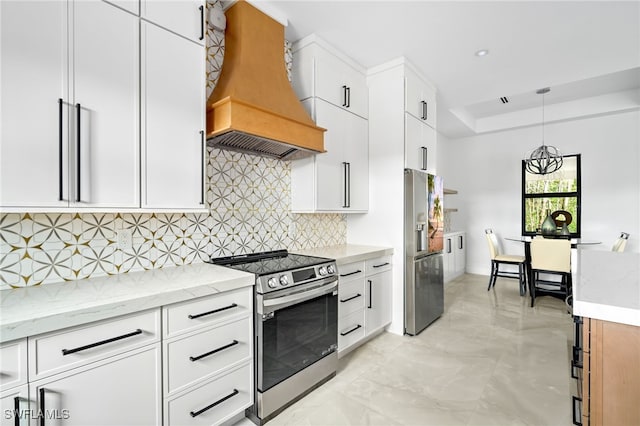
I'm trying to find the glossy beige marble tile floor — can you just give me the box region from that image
[251,274,575,426]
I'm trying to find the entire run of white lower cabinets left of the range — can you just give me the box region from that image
[0,287,254,426]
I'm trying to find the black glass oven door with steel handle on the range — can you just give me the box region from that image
[256,277,338,392]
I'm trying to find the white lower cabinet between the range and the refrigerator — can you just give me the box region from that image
[338,256,392,356]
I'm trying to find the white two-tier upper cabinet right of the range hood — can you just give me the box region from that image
[291,36,369,213]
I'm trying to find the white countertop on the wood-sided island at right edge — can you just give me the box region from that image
[573,250,640,326]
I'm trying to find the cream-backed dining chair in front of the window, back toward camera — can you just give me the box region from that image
[529,238,571,307]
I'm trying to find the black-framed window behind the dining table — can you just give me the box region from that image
[522,154,580,238]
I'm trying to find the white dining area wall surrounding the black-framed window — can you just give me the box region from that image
[438,111,640,275]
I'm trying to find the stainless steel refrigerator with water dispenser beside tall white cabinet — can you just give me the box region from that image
[404,169,444,335]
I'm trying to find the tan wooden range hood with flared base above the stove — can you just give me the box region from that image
[207,0,325,160]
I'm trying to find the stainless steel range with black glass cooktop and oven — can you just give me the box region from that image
[211,250,338,425]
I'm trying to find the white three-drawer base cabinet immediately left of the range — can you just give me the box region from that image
[162,287,253,426]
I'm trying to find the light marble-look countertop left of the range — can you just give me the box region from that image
[0,263,255,343]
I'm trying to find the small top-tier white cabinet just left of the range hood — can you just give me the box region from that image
[140,0,206,45]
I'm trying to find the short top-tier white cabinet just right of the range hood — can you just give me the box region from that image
[292,36,369,118]
